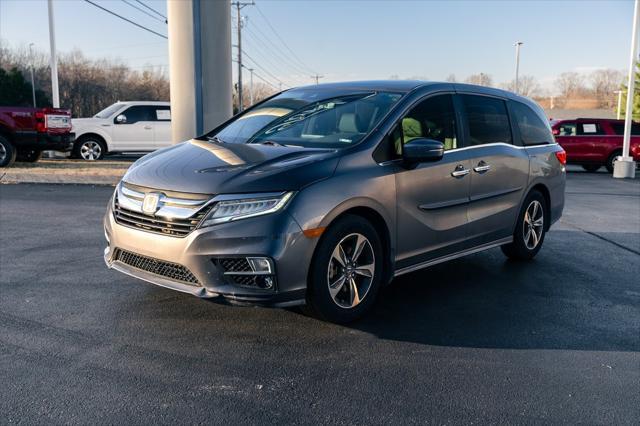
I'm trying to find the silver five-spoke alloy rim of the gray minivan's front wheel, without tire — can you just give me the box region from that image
[327,233,376,309]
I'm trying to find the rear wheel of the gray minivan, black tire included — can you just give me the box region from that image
[501,190,549,260]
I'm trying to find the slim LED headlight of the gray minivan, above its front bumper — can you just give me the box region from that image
[200,192,293,227]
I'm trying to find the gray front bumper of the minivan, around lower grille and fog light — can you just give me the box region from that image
[104,208,317,307]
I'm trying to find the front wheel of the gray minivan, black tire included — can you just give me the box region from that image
[304,215,385,324]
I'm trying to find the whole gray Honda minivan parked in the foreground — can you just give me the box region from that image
[104,81,566,322]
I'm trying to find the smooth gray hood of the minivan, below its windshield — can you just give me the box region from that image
[123,139,338,194]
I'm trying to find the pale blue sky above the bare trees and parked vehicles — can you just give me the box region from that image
[0,0,633,87]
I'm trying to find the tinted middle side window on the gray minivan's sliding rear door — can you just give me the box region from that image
[461,95,511,146]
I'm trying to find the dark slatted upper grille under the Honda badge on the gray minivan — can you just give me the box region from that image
[113,197,209,237]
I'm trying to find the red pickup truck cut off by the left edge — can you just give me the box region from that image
[0,106,74,167]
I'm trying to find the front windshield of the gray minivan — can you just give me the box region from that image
[215,89,402,148]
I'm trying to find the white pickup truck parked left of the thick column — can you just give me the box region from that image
[71,101,171,161]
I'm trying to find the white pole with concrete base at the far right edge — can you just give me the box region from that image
[613,0,640,178]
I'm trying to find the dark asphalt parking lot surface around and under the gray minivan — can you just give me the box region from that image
[0,173,640,424]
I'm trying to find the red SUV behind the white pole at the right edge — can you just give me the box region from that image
[551,118,640,173]
